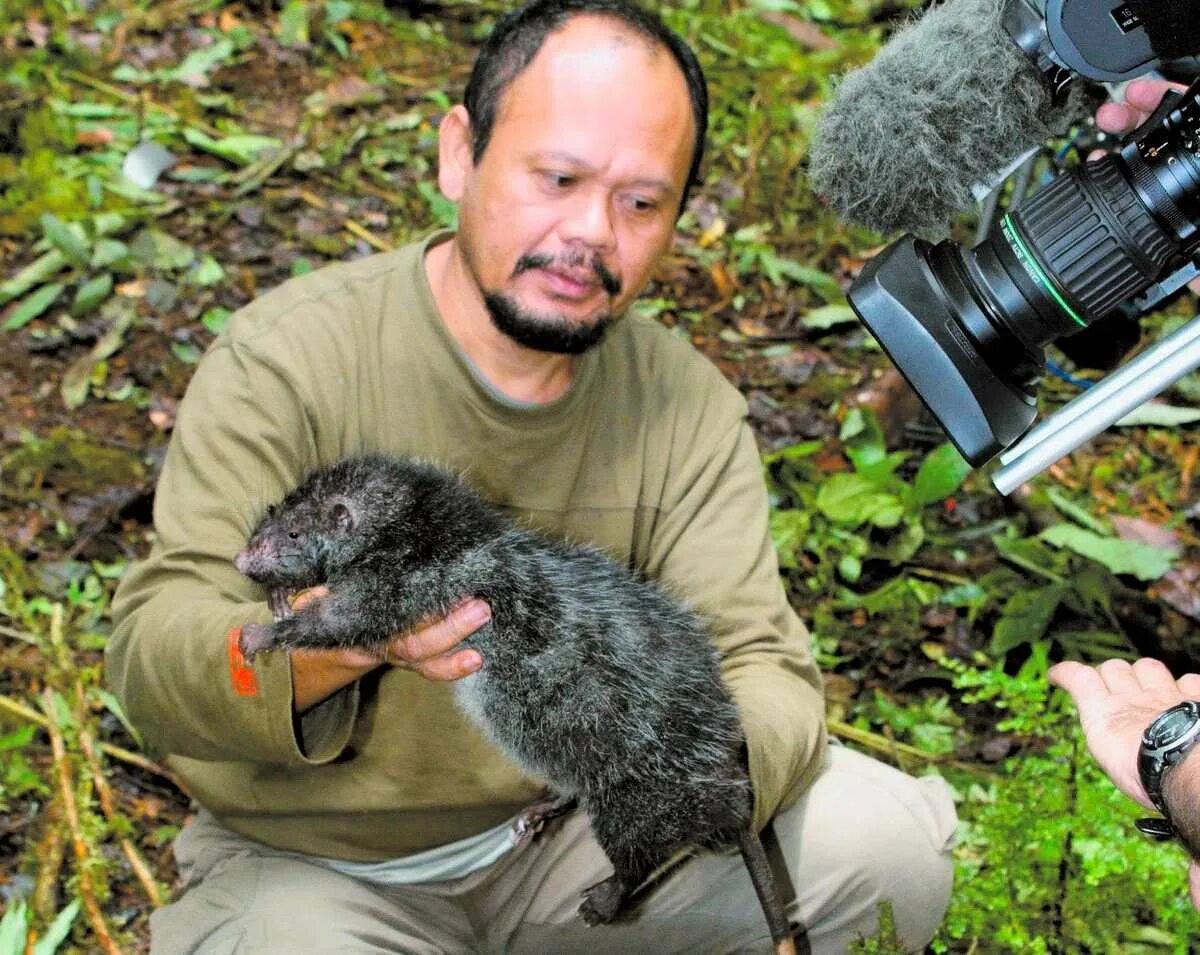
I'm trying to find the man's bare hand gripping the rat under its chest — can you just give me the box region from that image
[293,587,492,681]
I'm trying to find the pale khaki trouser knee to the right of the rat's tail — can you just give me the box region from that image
[776,746,956,951]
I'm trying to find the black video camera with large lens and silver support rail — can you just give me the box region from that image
[848,0,1200,493]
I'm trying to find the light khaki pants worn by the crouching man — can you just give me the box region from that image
[150,746,955,955]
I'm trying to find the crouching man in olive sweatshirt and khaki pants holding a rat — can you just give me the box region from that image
[108,0,955,953]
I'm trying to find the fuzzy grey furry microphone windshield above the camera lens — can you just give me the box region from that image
[809,0,1085,239]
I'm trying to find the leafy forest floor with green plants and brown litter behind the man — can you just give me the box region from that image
[0,0,1200,955]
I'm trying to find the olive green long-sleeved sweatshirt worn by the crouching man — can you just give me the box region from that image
[107,234,824,861]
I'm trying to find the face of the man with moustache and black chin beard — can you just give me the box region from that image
[443,16,695,353]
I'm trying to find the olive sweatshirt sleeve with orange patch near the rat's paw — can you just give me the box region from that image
[106,340,359,764]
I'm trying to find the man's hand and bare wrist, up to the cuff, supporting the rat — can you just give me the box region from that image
[290,587,492,713]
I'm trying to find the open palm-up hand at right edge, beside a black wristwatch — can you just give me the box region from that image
[1050,657,1200,811]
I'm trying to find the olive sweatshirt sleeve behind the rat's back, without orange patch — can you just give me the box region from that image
[647,398,826,829]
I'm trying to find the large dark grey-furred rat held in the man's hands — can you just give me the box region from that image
[235,455,787,942]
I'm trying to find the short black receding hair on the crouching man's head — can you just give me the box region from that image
[463,0,708,211]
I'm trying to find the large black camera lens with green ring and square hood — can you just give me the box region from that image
[850,82,1200,466]
